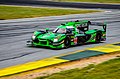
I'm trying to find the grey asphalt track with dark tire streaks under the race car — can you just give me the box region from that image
[0,10,120,68]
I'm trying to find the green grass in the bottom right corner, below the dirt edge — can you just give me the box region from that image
[36,58,120,79]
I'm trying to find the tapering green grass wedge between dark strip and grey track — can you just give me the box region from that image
[0,5,100,20]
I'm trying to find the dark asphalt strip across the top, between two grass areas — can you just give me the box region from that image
[0,0,120,9]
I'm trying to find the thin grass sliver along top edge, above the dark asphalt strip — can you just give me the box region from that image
[53,0,120,3]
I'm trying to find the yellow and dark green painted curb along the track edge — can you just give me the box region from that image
[0,43,120,77]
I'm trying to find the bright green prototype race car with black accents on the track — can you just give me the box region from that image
[27,20,107,48]
